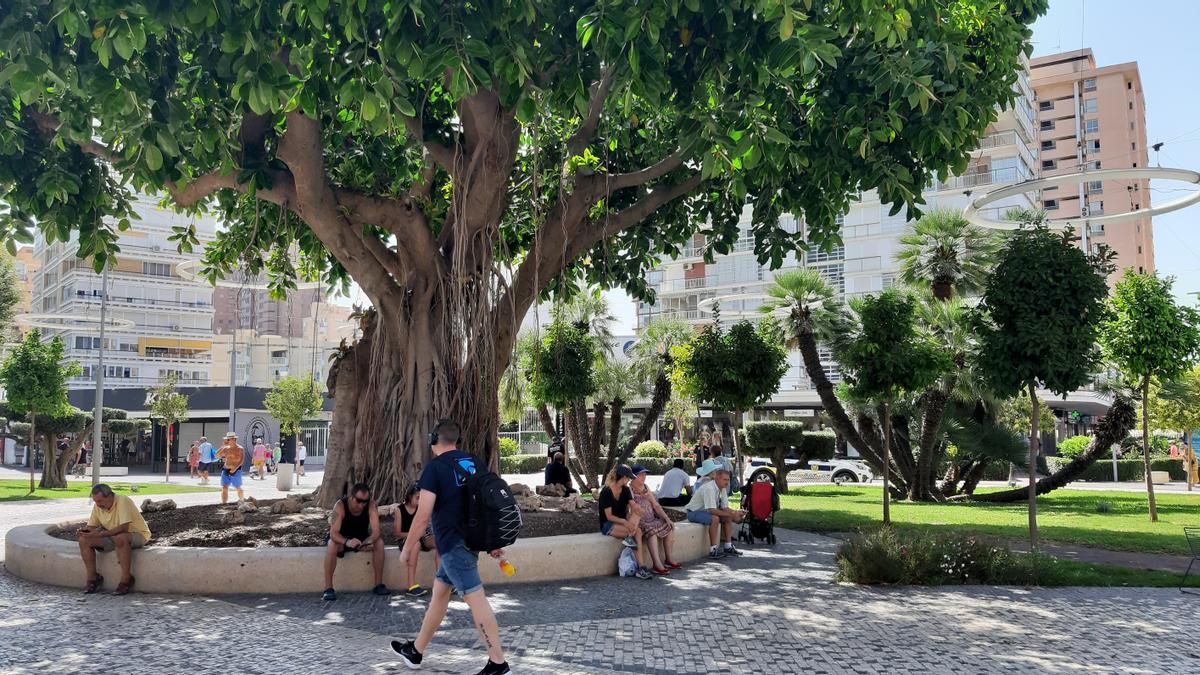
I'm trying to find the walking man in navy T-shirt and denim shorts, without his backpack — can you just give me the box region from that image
[391,419,510,675]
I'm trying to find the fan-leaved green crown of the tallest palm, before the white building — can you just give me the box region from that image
[896,209,1000,300]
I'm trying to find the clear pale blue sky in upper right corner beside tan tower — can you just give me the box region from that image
[1033,0,1200,304]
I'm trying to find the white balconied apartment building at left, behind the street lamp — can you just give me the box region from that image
[32,197,216,389]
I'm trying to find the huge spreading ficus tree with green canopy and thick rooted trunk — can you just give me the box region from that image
[0,0,1046,498]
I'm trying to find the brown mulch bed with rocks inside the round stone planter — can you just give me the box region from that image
[50,497,684,548]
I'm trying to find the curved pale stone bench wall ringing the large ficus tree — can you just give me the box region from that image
[5,522,708,595]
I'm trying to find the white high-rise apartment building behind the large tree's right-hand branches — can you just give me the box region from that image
[637,65,1039,410]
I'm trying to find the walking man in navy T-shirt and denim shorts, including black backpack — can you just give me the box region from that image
[391,419,511,675]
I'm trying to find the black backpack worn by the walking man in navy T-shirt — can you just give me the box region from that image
[449,456,521,551]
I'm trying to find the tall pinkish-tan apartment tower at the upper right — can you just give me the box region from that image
[1030,48,1154,276]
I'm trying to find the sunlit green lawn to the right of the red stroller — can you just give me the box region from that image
[779,485,1200,554]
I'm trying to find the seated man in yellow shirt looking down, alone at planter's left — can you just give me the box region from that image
[79,483,150,596]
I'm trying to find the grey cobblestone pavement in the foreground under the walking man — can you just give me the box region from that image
[0,530,1200,674]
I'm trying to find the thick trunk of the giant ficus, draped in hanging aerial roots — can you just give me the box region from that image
[320,302,508,503]
